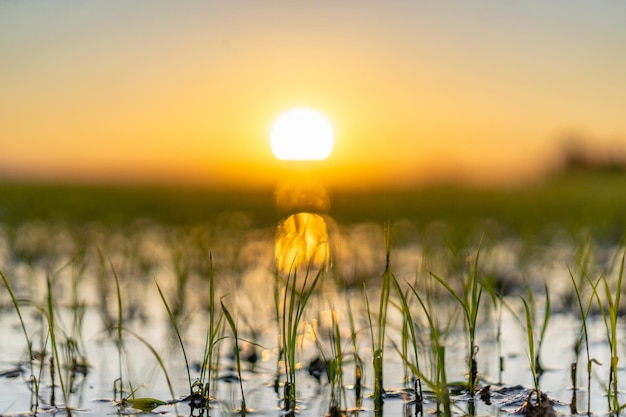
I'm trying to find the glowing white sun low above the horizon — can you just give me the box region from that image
[270,108,333,161]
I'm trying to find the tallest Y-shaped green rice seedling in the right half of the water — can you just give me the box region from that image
[431,245,483,396]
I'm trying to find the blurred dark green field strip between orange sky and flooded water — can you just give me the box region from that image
[0,171,626,243]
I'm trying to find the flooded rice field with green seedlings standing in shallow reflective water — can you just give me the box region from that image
[0,176,626,416]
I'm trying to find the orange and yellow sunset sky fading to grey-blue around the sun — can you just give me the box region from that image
[0,0,626,187]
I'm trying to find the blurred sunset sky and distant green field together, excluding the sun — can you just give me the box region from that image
[0,0,626,240]
